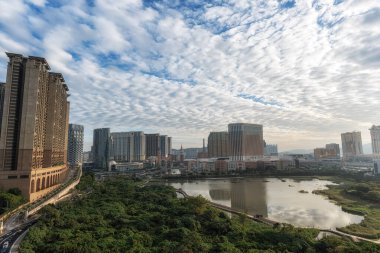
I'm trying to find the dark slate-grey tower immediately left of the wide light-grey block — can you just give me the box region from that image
[92,128,110,170]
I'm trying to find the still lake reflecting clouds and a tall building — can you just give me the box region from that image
[167,178,363,229]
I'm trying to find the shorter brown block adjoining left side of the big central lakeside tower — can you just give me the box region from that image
[207,132,228,157]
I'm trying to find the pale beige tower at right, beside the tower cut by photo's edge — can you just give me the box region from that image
[341,132,363,158]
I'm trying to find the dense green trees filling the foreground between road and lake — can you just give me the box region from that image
[20,174,380,253]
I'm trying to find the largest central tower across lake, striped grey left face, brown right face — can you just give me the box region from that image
[228,123,264,161]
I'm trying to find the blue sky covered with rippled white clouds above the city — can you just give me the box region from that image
[0,0,380,151]
